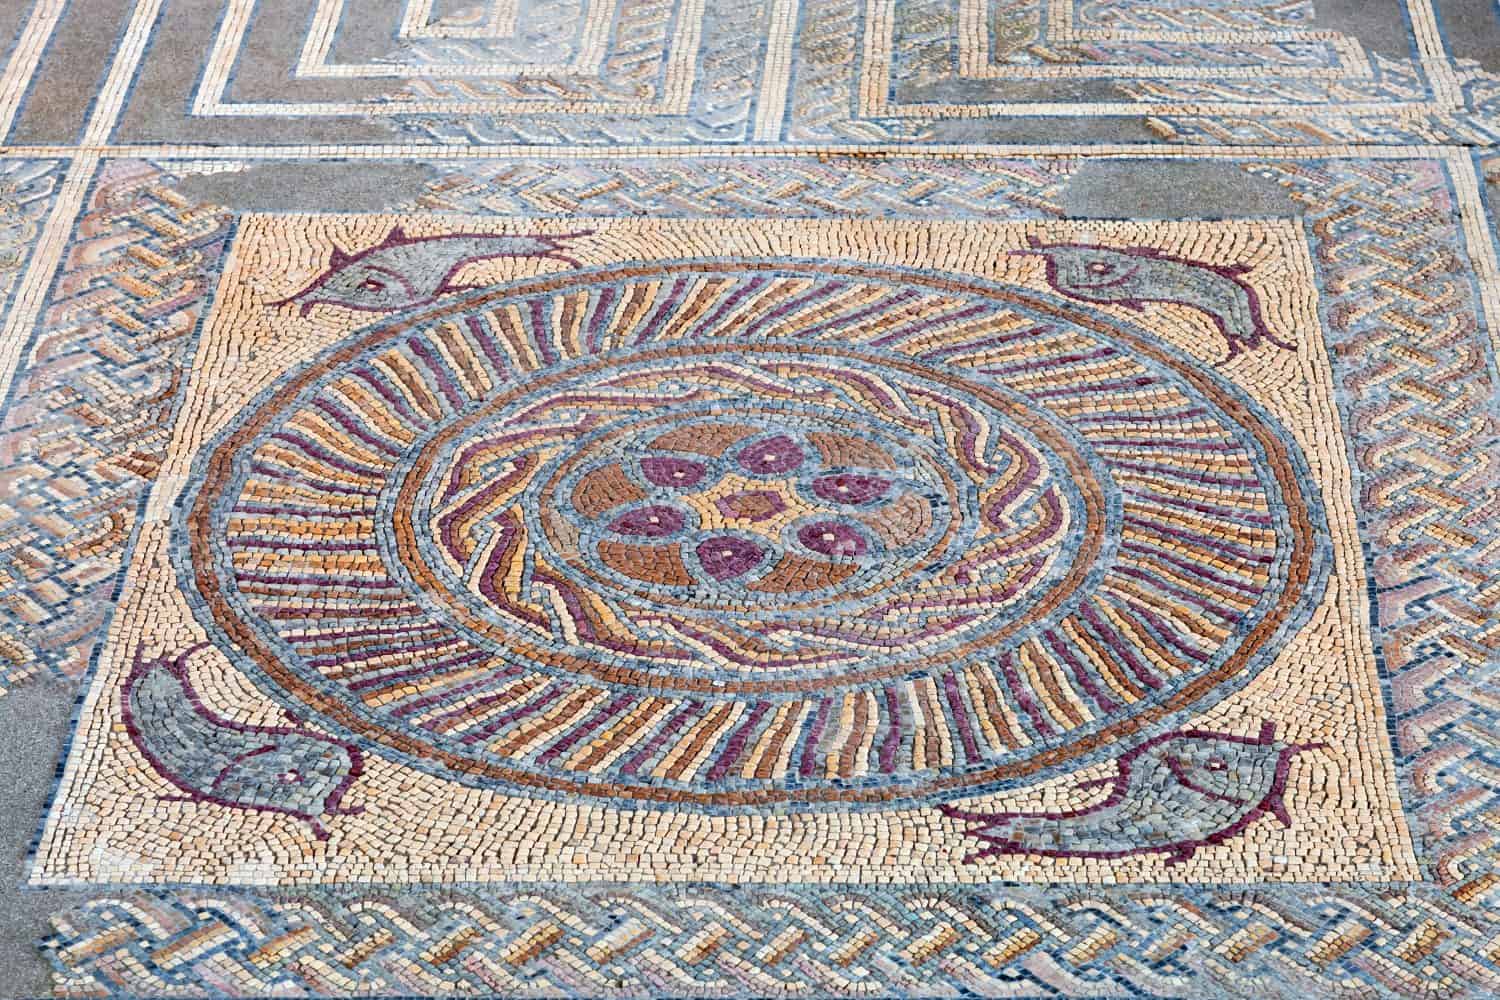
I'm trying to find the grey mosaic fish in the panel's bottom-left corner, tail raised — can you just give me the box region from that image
[122,645,365,840]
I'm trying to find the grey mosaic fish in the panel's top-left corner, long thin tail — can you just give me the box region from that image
[272,225,590,316]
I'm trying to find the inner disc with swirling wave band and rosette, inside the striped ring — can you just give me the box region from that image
[408,352,1103,687]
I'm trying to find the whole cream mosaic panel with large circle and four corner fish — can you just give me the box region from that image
[38,216,1415,882]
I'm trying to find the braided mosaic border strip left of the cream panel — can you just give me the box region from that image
[0,162,228,687]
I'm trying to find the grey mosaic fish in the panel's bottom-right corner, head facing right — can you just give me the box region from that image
[939,723,1326,864]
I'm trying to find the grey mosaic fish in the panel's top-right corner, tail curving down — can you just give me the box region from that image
[1011,237,1296,360]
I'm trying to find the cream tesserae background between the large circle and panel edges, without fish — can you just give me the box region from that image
[33,209,1416,885]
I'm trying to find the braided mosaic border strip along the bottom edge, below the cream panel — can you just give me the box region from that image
[47,885,1500,1000]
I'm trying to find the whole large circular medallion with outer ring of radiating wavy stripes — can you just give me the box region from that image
[180,261,1323,807]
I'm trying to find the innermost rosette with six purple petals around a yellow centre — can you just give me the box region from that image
[549,408,957,606]
